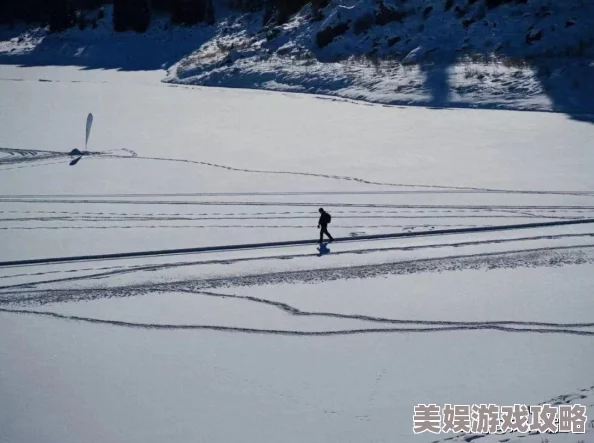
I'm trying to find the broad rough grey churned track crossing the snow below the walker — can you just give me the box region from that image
[0,244,594,305]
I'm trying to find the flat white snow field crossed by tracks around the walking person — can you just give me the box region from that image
[0,66,594,443]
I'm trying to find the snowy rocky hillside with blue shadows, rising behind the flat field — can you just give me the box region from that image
[0,0,594,116]
